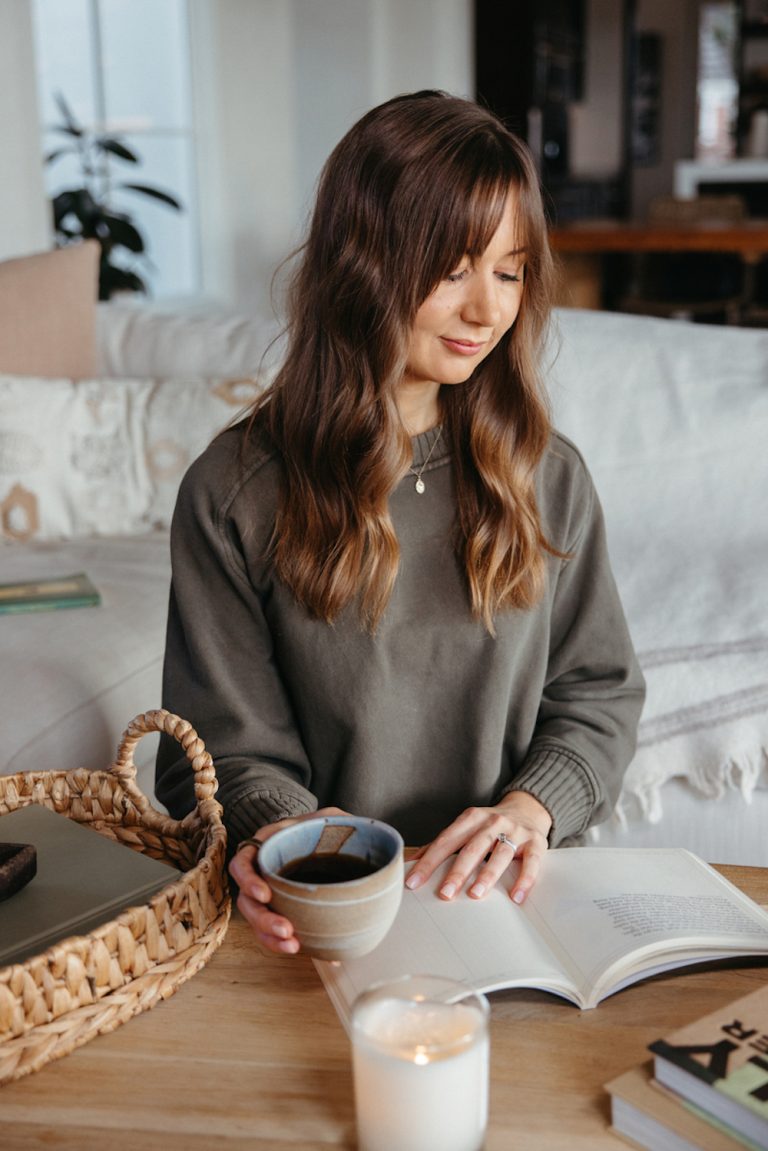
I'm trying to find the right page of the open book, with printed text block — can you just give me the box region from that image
[527,847,768,999]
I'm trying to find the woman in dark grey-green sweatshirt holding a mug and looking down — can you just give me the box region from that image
[157,92,642,953]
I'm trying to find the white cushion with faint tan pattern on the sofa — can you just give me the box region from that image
[0,376,260,543]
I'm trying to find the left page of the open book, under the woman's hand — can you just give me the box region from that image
[315,860,575,1024]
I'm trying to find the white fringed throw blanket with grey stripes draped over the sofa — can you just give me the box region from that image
[550,311,768,821]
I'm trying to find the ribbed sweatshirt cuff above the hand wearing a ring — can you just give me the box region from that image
[499,740,601,847]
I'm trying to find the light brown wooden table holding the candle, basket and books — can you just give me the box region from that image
[0,867,768,1151]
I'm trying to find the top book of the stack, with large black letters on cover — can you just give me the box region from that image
[651,973,768,1148]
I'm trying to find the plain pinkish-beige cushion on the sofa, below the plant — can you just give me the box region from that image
[0,241,99,380]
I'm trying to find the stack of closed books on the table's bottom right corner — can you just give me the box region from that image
[606,980,768,1151]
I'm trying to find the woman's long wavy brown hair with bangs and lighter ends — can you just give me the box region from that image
[251,91,553,633]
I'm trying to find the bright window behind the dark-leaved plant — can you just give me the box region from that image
[35,0,200,299]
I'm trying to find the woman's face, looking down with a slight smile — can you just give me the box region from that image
[397,193,525,430]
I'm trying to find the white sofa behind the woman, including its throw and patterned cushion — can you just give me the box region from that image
[0,249,768,866]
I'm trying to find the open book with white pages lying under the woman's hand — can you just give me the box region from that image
[315,847,768,1024]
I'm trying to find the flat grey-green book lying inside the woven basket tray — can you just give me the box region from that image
[0,803,181,967]
